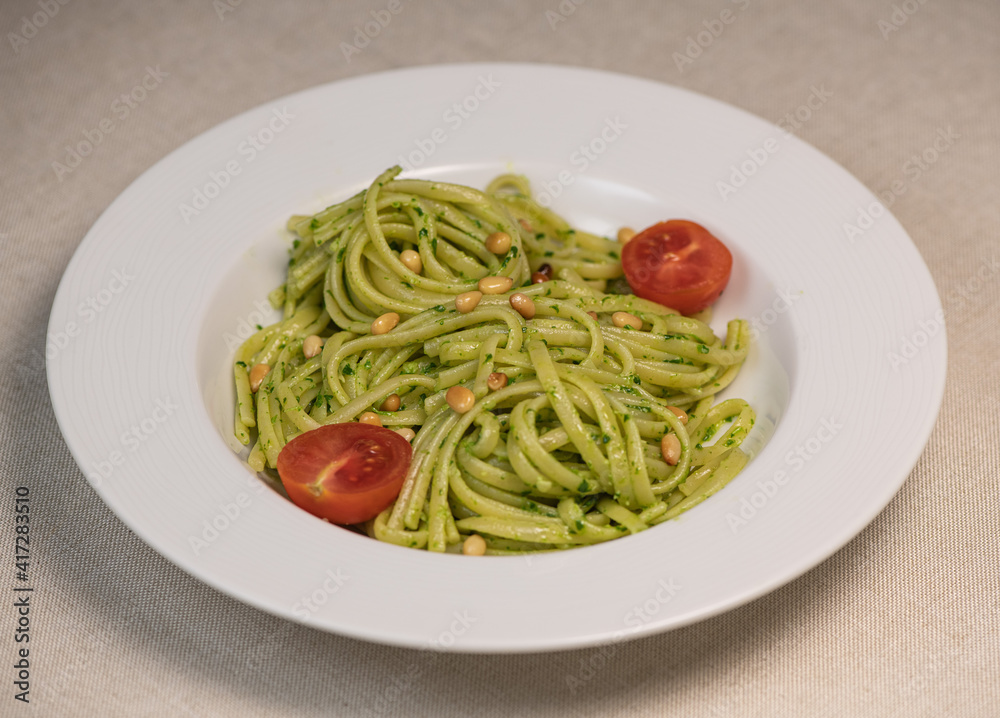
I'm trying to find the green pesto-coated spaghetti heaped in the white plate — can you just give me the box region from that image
[234,167,754,554]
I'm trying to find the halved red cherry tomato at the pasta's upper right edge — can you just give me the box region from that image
[622,219,733,314]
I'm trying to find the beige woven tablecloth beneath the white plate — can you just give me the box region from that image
[0,0,1000,718]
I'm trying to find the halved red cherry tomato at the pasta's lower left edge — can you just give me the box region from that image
[278,422,413,525]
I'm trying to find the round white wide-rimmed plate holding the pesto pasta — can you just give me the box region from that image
[48,64,945,651]
